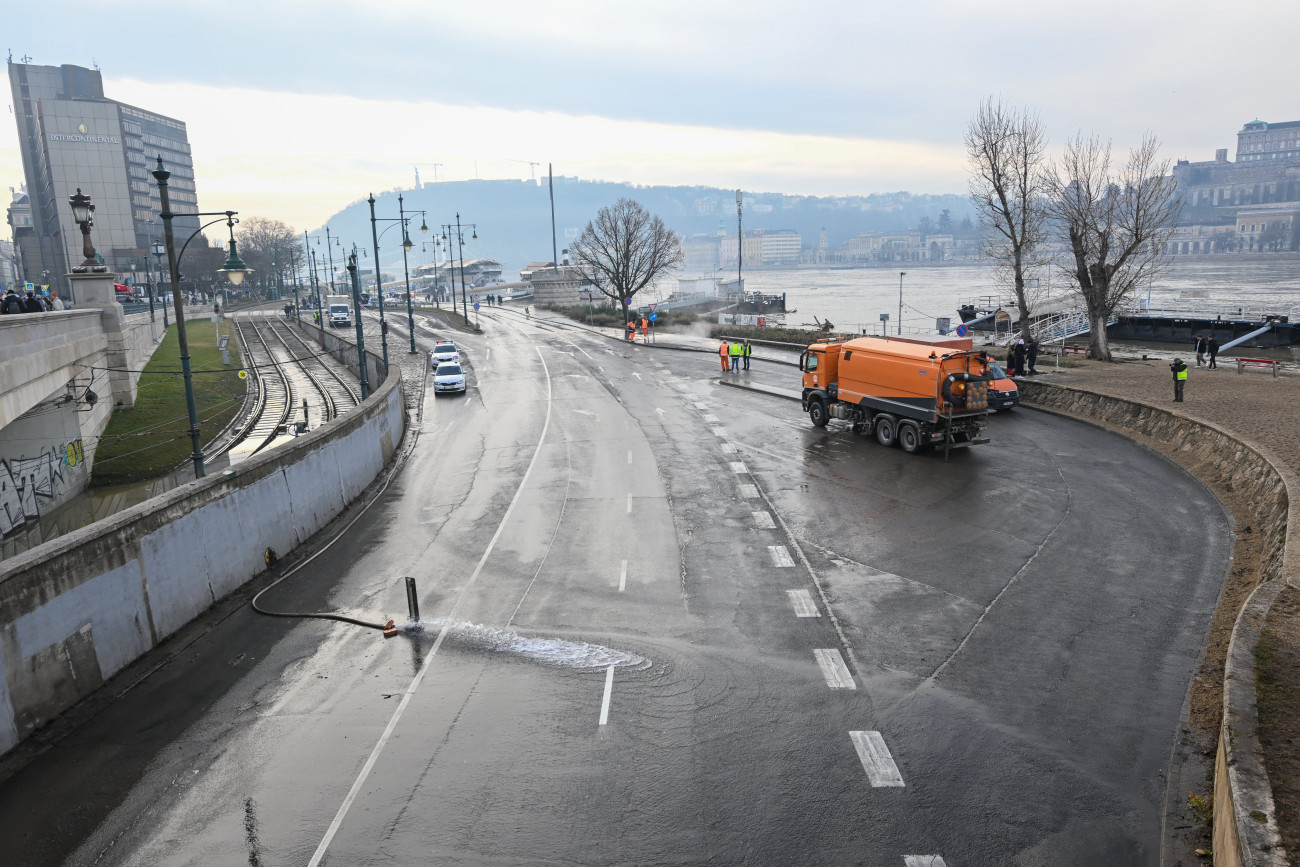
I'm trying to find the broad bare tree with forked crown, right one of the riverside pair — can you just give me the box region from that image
[1048,133,1183,361]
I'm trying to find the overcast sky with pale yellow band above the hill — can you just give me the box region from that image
[0,0,1300,229]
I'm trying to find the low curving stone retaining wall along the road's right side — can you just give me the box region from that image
[1019,380,1300,867]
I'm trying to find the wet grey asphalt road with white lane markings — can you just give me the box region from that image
[0,309,1230,867]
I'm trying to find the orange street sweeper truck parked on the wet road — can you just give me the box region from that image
[800,337,992,454]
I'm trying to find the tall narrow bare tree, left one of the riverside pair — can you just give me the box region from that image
[966,96,1047,335]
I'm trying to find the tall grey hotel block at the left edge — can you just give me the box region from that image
[9,60,199,296]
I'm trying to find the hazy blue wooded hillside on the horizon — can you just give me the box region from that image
[329,178,975,279]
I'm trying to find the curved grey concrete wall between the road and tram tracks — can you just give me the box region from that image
[0,351,406,751]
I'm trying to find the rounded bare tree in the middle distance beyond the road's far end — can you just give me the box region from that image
[569,199,681,323]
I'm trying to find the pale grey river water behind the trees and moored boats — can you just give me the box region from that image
[712,256,1300,331]
